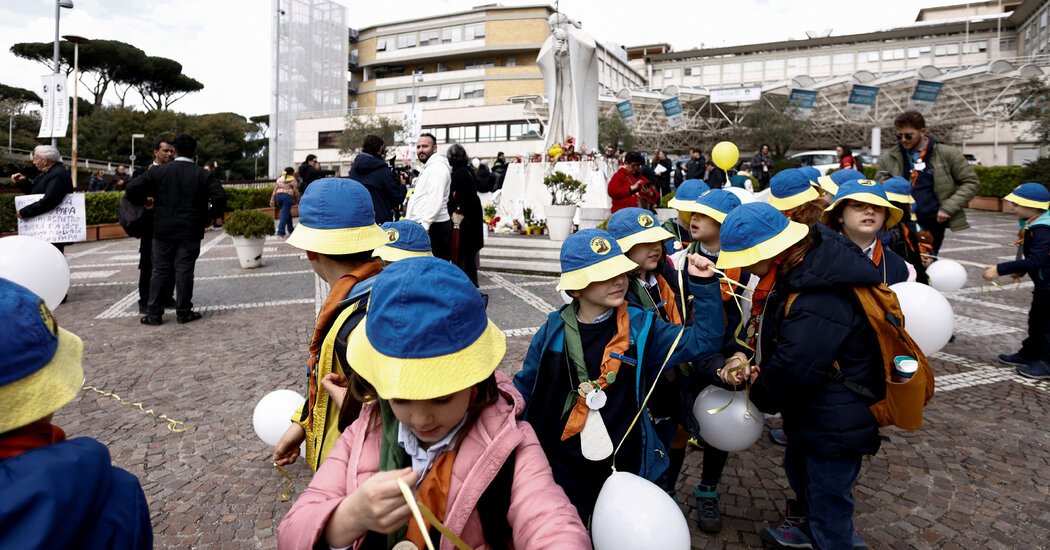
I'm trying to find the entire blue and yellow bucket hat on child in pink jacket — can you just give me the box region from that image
[347,257,507,400]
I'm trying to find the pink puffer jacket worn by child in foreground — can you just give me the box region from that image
[277,372,591,550]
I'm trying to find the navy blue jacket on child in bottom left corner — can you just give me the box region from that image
[0,438,153,550]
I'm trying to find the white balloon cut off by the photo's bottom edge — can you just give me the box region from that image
[591,471,690,550]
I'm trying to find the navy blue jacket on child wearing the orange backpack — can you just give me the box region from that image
[751,224,885,459]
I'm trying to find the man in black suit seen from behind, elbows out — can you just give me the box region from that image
[127,133,226,325]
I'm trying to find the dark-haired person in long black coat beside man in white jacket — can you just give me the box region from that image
[448,144,485,287]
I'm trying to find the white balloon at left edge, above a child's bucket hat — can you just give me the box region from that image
[0,235,69,310]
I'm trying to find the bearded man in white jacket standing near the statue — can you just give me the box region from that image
[404,133,453,259]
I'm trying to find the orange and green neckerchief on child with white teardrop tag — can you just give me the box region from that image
[562,301,642,441]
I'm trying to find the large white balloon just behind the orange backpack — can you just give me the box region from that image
[889,281,956,357]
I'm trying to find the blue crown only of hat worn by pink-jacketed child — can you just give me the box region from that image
[364,256,488,359]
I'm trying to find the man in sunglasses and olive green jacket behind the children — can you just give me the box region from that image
[879,111,978,255]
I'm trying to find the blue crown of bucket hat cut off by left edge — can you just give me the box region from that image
[0,279,59,385]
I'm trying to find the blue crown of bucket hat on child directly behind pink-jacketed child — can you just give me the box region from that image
[299,177,376,230]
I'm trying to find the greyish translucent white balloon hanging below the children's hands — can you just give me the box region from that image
[693,386,764,452]
